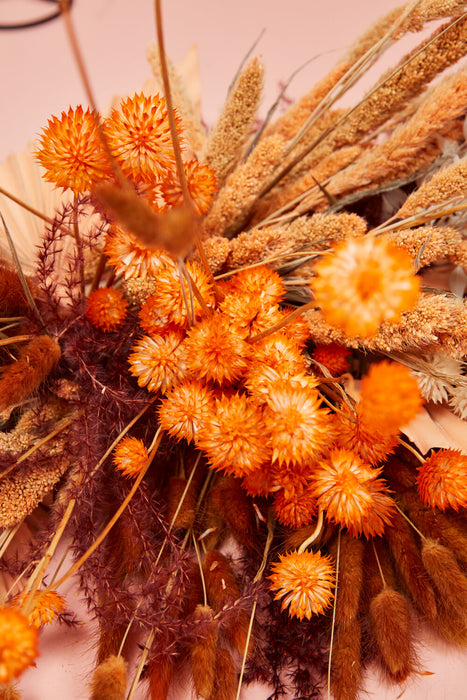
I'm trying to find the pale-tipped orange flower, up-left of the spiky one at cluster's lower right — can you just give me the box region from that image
[264,380,329,464]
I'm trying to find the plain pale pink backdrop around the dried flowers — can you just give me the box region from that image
[0,0,467,700]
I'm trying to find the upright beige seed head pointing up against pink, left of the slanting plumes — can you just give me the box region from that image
[203,58,264,187]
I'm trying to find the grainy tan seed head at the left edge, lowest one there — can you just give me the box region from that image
[0,455,71,528]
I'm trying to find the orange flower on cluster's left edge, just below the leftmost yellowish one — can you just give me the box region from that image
[159,380,214,442]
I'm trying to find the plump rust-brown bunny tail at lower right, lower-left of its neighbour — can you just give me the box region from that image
[370,588,416,683]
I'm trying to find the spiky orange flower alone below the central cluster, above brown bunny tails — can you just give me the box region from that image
[268,551,335,620]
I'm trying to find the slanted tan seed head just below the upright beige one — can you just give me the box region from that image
[202,136,284,238]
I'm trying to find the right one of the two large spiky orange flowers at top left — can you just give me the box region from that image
[105,93,182,182]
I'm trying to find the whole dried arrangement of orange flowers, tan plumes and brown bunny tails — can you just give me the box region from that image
[0,0,467,700]
